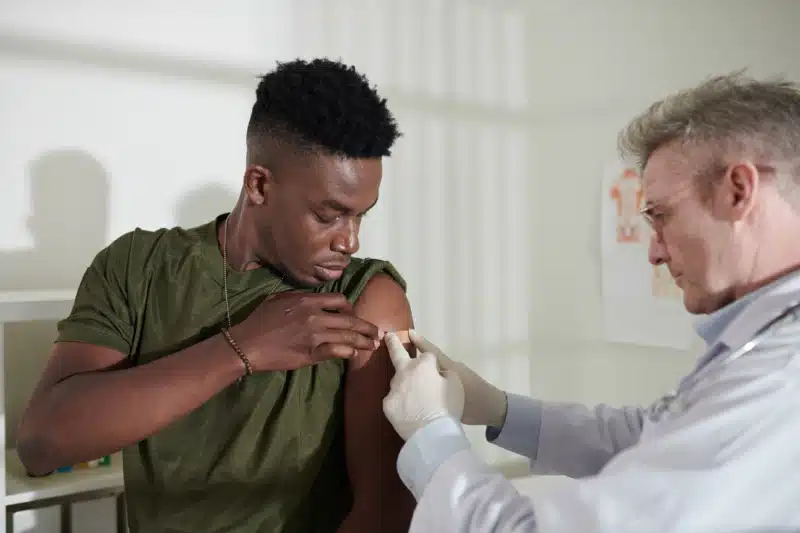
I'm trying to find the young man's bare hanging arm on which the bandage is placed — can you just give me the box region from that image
[345,274,414,531]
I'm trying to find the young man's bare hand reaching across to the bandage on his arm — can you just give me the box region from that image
[231,292,382,372]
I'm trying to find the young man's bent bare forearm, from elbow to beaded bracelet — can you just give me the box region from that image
[18,335,244,475]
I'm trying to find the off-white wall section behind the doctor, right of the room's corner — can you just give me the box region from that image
[529,0,800,403]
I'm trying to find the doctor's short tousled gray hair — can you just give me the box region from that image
[618,71,800,183]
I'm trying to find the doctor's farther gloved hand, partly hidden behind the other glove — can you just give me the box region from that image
[408,330,508,428]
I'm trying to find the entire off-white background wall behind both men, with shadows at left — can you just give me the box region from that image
[0,0,800,533]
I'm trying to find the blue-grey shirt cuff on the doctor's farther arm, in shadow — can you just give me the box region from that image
[486,393,542,461]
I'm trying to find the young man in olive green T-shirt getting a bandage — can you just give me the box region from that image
[18,60,413,533]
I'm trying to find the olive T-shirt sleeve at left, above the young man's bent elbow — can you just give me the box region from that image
[56,234,134,355]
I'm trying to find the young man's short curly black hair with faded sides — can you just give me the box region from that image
[247,59,401,159]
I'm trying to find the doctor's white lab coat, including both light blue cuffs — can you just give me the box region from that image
[398,275,800,533]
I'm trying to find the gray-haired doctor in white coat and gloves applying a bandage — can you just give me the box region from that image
[384,70,800,533]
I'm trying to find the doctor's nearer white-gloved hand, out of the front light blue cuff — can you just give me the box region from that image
[383,333,464,440]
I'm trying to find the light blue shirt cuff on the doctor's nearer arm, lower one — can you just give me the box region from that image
[397,416,470,500]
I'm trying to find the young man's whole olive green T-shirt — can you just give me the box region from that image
[57,215,405,533]
